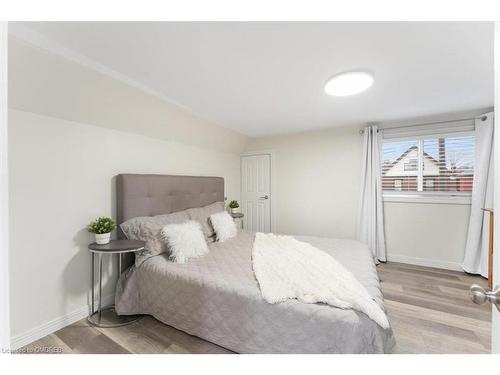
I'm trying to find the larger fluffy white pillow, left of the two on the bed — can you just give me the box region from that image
[161,220,208,263]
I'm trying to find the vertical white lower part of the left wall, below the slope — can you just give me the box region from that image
[9,110,240,346]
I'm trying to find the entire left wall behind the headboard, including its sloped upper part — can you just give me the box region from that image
[8,39,246,347]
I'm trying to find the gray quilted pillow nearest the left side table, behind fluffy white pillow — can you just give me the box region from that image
[120,211,189,267]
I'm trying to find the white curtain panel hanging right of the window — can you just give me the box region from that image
[462,112,493,277]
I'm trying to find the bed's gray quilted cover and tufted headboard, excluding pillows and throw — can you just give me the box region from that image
[115,175,394,353]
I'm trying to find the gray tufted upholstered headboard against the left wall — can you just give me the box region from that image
[116,174,224,268]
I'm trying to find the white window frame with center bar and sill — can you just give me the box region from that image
[382,131,475,205]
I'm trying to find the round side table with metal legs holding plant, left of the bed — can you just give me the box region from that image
[87,240,145,328]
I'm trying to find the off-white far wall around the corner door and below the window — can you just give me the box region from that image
[246,127,470,269]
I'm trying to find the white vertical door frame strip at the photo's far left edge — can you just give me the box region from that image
[0,21,10,354]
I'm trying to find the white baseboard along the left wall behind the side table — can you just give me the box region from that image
[10,295,115,350]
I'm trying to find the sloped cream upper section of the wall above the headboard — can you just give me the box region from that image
[9,36,247,152]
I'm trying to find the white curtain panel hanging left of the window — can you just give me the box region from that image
[357,125,386,263]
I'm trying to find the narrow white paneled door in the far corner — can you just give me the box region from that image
[241,154,272,232]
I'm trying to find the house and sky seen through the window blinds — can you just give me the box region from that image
[382,135,474,193]
